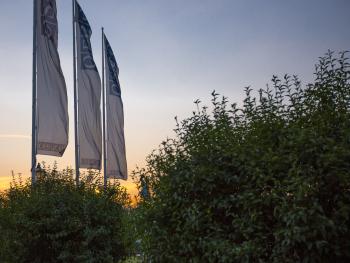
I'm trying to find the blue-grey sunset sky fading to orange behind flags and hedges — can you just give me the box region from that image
[0,0,350,193]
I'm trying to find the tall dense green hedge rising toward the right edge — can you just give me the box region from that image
[134,52,350,262]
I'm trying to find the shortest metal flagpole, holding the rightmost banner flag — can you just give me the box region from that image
[102,27,107,188]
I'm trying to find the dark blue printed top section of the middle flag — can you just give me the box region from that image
[77,3,97,71]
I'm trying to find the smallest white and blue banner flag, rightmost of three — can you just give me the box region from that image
[103,34,128,180]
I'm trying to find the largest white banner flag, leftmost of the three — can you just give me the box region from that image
[33,0,68,156]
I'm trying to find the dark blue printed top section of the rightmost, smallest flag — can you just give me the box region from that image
[105,38,121,97]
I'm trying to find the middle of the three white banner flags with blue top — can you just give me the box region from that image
[75,3,102,169]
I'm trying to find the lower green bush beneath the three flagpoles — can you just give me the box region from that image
[0,166,133,263]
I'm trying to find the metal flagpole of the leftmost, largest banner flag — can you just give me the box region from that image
[31,0,37,185]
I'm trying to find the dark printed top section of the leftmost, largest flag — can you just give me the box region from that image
[41,0,58,47]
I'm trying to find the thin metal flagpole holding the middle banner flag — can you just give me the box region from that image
[72,0,80,186]
